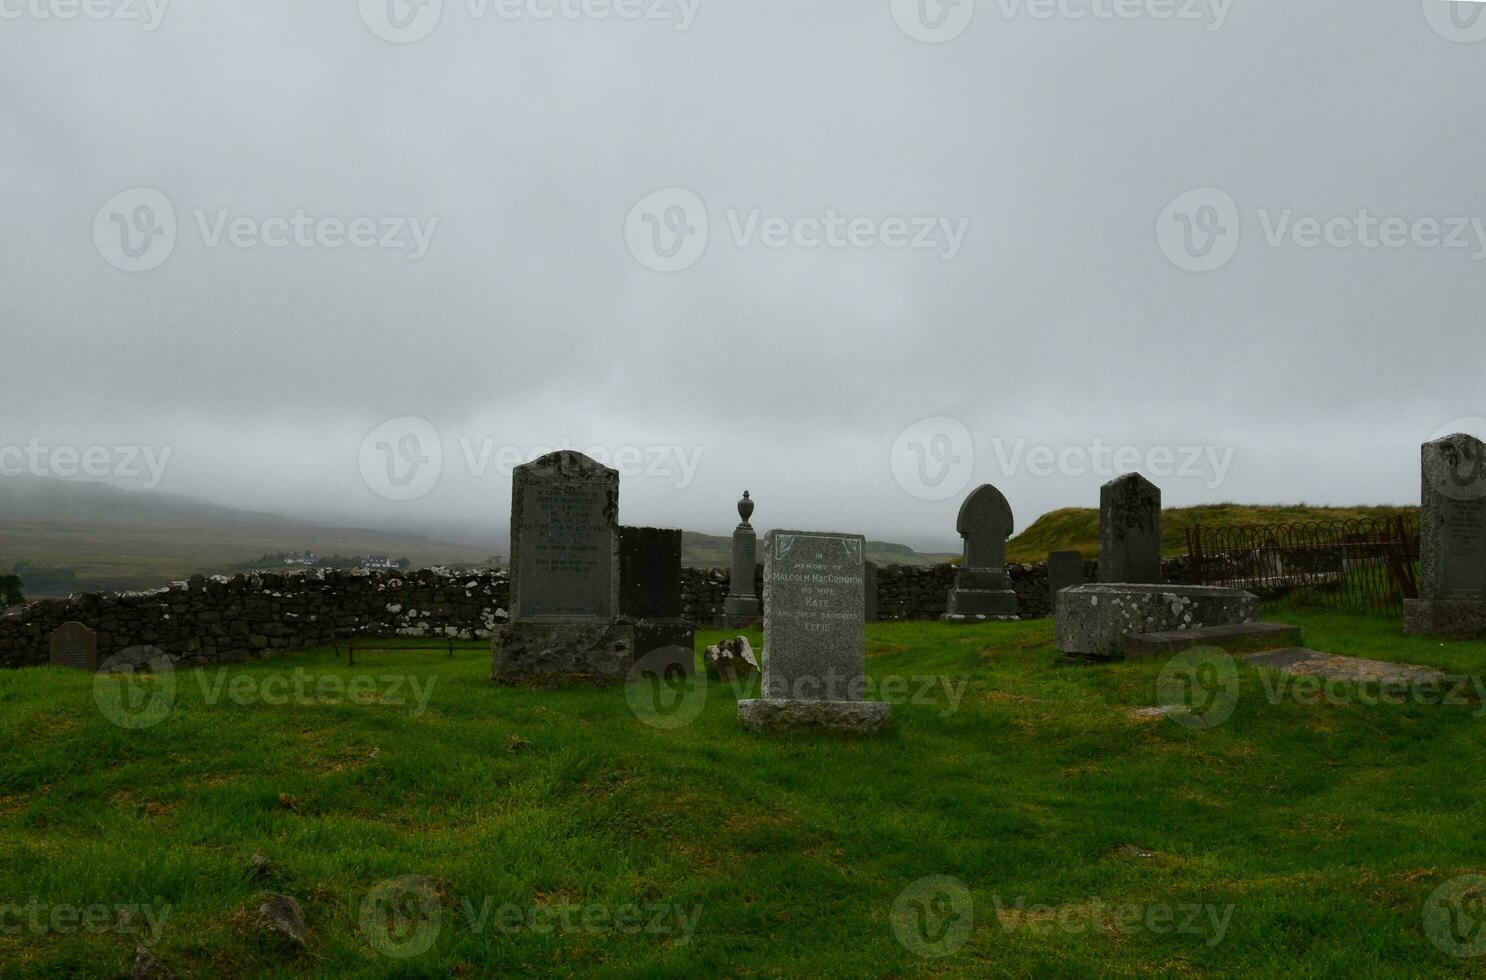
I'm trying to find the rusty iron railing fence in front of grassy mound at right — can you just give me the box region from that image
[1187,516,1419,614]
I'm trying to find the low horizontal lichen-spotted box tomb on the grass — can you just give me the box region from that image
[1057,584,1259,660]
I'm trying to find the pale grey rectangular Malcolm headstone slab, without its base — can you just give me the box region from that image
[764,531,866,700]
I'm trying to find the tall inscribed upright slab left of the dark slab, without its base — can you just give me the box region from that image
[511,451,620,622]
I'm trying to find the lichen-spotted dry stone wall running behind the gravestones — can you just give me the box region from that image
[0,558,1187,668]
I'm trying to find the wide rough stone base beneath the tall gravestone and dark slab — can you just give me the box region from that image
[490,620,697,686]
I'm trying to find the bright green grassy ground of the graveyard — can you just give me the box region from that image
[0,610,1486,977]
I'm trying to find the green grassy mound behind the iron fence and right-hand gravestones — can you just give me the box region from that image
[1006,504,1419,562]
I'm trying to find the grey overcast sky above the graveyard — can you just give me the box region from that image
[0,0,1486,547]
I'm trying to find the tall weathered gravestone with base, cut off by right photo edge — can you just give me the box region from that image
[1404,434,1486,636]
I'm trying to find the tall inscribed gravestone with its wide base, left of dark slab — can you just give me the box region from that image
[490,451,692,684]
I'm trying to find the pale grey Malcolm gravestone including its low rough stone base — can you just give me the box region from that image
[739,531,893,732]
